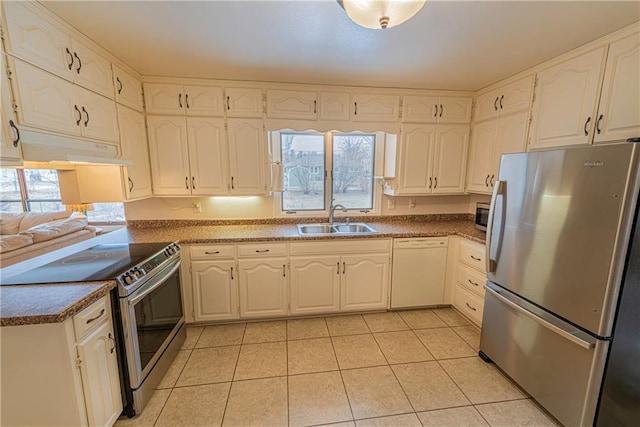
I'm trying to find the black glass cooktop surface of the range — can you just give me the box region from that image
[0,243,170,285]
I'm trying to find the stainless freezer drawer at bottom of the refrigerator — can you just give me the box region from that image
[480,283,609,426]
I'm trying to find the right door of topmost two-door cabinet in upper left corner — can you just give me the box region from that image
[71,40,113,99]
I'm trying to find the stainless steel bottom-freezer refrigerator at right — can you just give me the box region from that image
[480,143,640,427]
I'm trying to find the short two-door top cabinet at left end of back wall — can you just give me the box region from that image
[144,83,224,117]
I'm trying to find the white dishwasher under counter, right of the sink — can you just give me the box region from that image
[391,237,448,308]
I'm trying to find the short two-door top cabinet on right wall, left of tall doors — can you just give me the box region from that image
[474,74,533,122]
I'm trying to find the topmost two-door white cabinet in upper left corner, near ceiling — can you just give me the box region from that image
[3,2,113,98]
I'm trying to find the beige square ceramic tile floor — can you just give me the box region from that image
[116,308,555,427]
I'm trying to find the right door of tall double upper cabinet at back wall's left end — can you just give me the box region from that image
[187,117,228,195]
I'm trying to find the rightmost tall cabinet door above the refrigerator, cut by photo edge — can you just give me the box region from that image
[594,34,640,142]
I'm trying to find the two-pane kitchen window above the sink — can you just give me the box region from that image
[271,131,380,215]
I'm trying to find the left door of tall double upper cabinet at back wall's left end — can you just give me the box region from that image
[147,116,191,196]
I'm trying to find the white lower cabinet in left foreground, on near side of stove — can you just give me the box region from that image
[0,296,122,426]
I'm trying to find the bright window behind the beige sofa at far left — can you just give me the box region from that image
[0,168,125,224]
